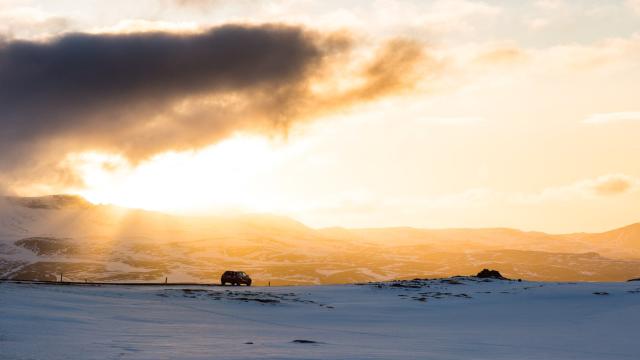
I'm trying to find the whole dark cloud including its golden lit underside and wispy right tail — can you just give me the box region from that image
[0,25,430,188]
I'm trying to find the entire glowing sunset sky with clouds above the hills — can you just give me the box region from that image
[0,0,640,233]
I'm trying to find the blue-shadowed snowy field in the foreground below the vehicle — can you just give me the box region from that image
[0,278,640,360]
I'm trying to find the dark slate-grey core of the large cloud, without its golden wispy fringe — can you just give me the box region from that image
[0,26,322,153]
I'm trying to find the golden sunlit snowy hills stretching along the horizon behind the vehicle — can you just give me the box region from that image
[0,195,640,285]
